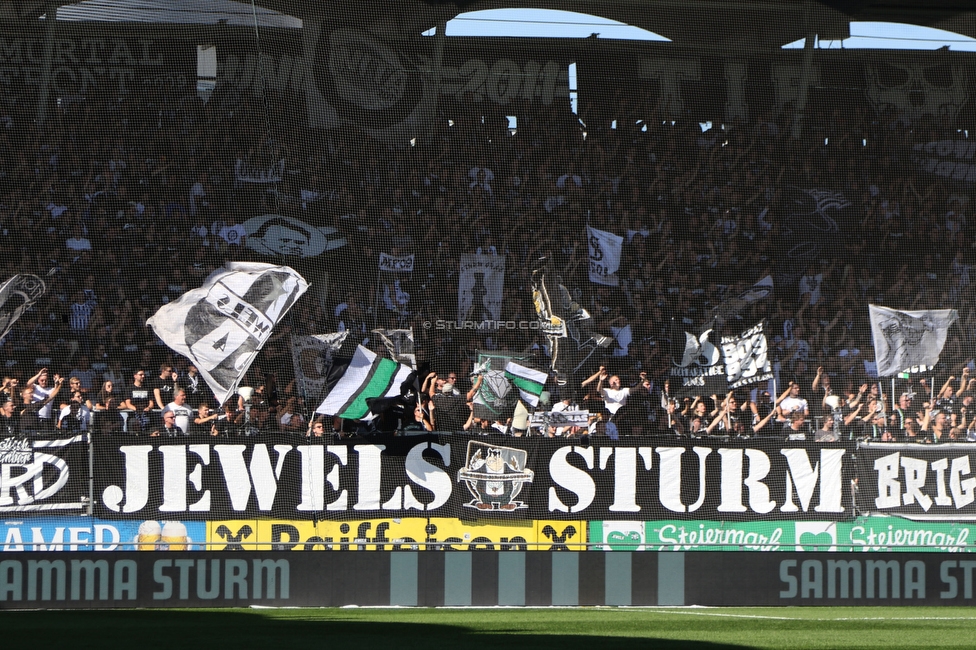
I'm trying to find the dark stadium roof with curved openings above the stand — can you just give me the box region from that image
[0,0,976,53]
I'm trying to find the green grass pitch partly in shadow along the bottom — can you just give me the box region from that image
[0,607,976,650]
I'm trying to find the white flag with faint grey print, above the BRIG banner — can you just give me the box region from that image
[868,305,959,377]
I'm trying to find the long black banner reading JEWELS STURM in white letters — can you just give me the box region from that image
[94,435,854,520]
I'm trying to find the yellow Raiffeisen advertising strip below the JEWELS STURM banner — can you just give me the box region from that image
[207,518,586,551]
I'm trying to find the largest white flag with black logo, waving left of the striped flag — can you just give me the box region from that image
[146,262,308,403]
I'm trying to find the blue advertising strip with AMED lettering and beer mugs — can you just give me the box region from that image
[0,516,207,552]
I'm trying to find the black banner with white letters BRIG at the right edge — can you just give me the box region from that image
[857,443,976,520]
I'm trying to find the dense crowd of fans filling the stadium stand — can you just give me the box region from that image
[0,76,976,441]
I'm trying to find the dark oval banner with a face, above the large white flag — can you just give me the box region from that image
[244,214,346,258]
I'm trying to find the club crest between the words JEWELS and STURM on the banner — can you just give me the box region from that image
[458,440,535,511]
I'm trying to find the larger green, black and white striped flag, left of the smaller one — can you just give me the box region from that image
[315,345,413,420]
